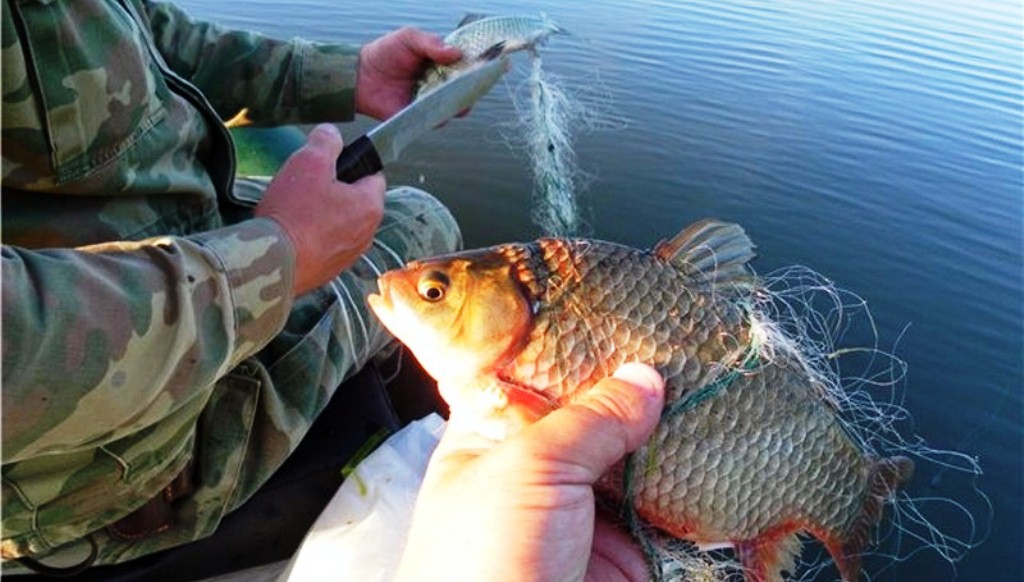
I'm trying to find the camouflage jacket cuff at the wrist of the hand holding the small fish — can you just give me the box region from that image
[297,40,359,123]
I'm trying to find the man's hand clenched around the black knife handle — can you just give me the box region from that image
[256,124,386,296]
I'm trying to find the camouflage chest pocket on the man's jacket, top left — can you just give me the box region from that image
[9,0,171,184]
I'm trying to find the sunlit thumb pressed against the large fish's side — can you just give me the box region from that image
[522,364,665,483]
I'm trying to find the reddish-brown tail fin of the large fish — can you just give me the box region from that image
[825,457,913,582]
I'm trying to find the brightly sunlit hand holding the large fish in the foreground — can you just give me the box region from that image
[397,364,665,582]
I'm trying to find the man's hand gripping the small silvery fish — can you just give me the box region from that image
[355,27,462,119]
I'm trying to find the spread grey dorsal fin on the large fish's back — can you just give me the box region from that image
[653,218,755,287]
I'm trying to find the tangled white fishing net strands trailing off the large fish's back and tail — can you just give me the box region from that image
[759,266,992,580]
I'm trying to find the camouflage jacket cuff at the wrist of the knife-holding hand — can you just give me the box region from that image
[189,218,295,361]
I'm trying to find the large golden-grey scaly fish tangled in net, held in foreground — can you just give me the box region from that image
[370,220,913,582]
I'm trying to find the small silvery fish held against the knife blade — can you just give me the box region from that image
[417,14,565,96]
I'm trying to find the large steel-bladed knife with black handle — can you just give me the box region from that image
[337,58,507,183]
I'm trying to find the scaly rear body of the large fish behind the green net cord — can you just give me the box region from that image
[618,364,869,543]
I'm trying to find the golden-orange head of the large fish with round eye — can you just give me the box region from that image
[368,249,532,383]
